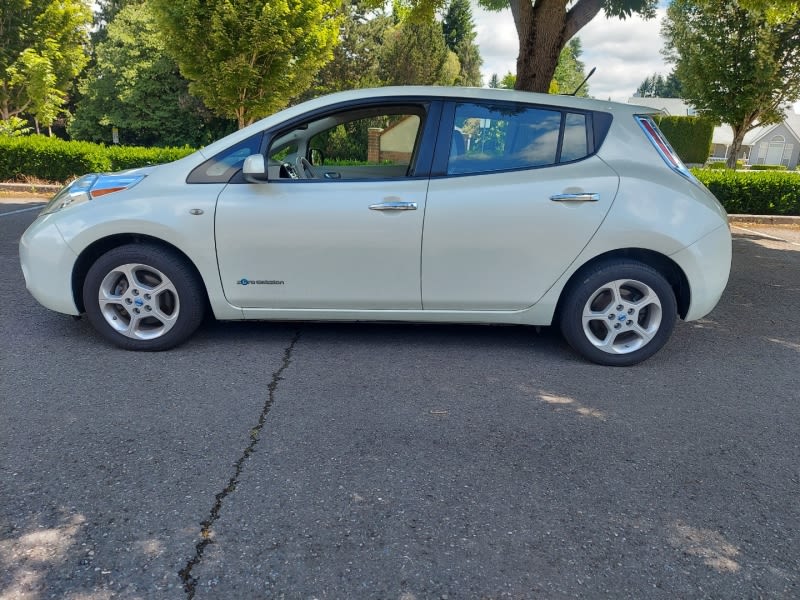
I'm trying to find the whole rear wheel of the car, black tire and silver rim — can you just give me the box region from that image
[559,259,678,367]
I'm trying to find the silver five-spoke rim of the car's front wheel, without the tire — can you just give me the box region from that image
[98,264,180,340]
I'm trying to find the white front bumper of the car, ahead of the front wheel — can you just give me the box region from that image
[19,215,80,315]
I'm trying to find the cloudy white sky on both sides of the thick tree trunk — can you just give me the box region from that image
[472,3,672,102]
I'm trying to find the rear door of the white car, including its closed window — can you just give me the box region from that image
[422,101,619,311]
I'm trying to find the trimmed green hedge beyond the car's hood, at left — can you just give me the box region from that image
[0,135,194,182]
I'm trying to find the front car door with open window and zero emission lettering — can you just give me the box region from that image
[216,101,439,310]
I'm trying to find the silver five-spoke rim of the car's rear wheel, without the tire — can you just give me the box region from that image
[583,279,662,354]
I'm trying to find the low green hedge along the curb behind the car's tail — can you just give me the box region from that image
[692,169,800,216]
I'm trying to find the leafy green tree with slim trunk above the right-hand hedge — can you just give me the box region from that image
[662,0,800,168]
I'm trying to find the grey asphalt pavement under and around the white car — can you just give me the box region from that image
[0,201,800,600]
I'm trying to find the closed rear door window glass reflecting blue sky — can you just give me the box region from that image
[447,104,590,175]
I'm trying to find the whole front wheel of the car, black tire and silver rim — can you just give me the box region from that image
[83,244,206,352]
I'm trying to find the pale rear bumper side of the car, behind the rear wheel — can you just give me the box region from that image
[671,224,732,321]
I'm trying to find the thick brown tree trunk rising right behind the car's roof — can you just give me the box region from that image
[510,0,603,94]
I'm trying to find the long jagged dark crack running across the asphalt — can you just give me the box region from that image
[178,331,300,600]
